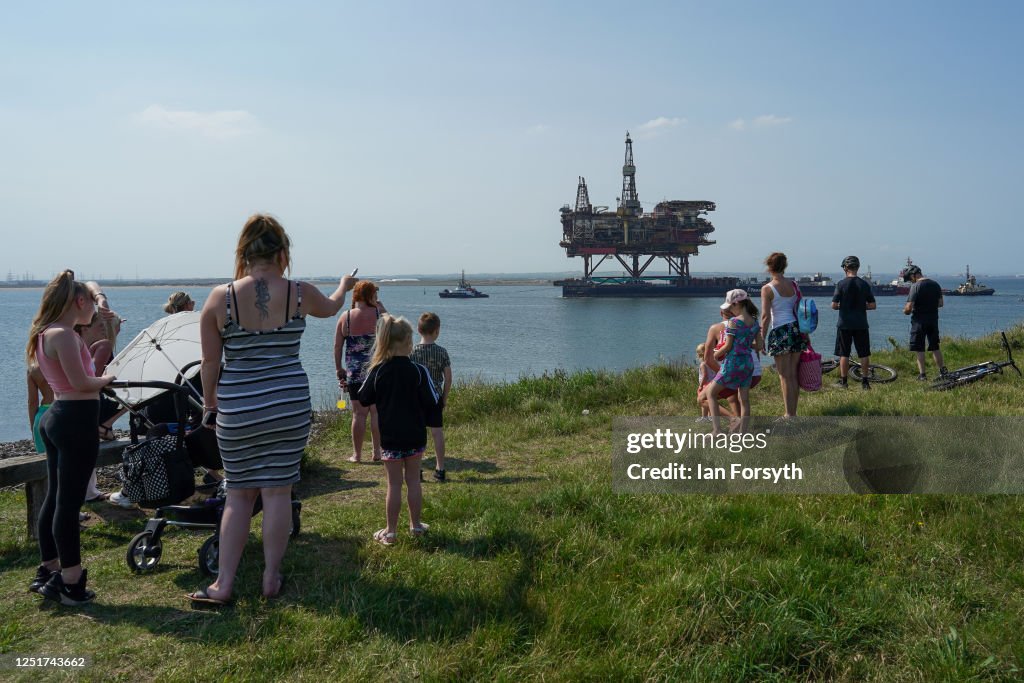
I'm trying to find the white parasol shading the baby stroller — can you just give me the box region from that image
[103,310,203,407]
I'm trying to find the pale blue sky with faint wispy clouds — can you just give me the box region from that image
[0,0,1024,279]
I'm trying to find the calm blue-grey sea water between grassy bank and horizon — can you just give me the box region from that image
[0,278,1024,441]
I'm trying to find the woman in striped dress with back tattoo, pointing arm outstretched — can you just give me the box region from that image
[188,214,355,604]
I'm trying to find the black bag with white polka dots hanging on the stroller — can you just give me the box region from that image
[121,434,196,507]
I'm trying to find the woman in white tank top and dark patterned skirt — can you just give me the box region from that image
[761,252,807,418]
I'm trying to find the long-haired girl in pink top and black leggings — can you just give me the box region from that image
[26,270,114,605]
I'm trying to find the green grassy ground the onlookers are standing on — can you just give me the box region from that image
[0,328,1024,681]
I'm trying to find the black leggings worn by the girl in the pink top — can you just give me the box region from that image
[37,400,99,567]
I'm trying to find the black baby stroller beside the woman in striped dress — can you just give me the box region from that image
[109,378,302,575]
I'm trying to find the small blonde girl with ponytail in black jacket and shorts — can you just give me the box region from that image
[358,314,439,546]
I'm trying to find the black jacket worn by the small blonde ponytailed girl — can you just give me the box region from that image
[359,355,439,451]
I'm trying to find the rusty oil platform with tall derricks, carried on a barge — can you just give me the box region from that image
[555,132,738,298]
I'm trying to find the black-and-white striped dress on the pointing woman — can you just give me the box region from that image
[217,283,311,488]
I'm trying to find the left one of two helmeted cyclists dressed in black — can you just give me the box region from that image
[833,256,876,389]
